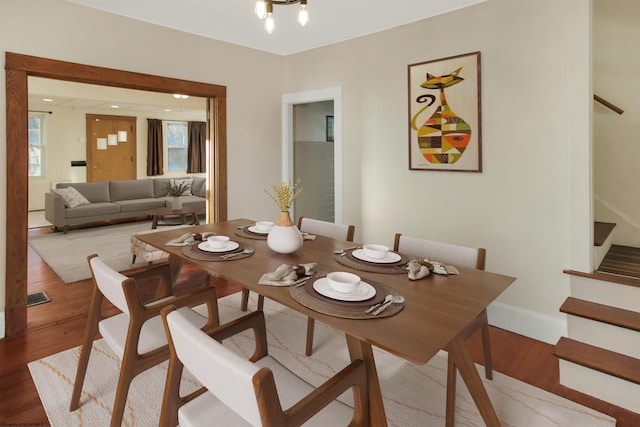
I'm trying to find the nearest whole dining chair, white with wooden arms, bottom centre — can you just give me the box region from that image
[160,307,369,427]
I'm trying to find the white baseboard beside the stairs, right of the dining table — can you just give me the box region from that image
[487,302,567,345]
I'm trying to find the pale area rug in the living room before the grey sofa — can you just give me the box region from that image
[29,221,186,283]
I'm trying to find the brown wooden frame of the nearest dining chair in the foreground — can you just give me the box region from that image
[159,307,370,427]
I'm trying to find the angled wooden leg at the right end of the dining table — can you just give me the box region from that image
[447,335,500,427]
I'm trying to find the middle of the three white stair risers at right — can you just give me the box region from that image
[567,315,640,359]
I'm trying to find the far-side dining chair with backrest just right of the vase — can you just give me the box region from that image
[242,216,356,356]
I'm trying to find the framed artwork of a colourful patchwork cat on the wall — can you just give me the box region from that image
[408,52,482,172]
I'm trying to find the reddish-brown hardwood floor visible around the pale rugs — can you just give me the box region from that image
[0,226,640,427]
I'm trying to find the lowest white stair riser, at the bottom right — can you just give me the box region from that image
[559,359,640,413]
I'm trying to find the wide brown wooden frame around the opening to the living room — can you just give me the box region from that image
[5,52,227,337]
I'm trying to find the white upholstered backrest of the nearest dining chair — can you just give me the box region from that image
[167,311,262,426]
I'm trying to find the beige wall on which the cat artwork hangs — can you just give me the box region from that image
[285,0,591,341]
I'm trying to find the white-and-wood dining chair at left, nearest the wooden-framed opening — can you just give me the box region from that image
[69,254,219,427]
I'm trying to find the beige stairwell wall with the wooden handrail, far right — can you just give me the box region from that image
[593,0,640,247]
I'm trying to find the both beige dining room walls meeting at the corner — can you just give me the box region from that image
[0,0,591,342]
